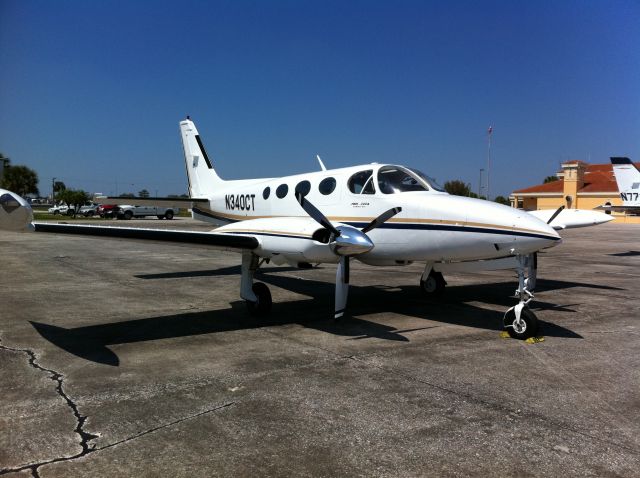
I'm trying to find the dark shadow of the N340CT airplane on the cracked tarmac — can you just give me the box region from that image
[31,267,596,366]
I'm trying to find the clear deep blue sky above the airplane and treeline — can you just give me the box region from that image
[0,0,640,196]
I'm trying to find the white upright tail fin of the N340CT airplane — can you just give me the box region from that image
[180,117,224,198]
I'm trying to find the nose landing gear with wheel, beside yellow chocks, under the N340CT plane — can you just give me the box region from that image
[503,254,539,340]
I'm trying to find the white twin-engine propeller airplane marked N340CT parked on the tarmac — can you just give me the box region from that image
[0,117,610,339]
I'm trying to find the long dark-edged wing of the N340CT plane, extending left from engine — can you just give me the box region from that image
[34,222,260,251]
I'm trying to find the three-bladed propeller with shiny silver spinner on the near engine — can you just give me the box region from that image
[296,192,402,319]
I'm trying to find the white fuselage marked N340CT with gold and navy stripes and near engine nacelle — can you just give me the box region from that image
[186,164,560,265]
